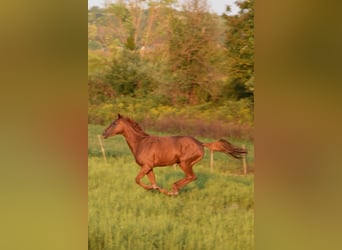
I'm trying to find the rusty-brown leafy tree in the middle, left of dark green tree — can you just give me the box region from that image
[169,0,222,104]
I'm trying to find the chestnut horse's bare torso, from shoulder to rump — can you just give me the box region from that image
[136,136,204,166]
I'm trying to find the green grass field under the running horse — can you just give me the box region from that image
[88,125,254,250]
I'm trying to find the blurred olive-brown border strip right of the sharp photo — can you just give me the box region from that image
[255,0,342,250]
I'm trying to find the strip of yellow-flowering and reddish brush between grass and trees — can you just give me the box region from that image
[88,97,253,139]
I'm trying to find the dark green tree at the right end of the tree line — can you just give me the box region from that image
[224,0,254,99]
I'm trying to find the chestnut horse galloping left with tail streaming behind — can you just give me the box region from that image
[102,114,247,195]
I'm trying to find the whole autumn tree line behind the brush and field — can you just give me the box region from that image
[88,0,254,133]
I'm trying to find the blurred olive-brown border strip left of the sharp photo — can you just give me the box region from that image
[0,1,87,249]
